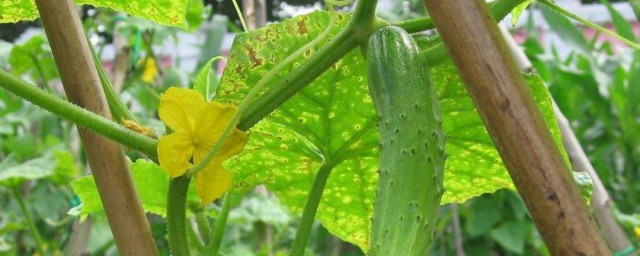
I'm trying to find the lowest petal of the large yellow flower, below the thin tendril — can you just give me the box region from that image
[196,162,232,206]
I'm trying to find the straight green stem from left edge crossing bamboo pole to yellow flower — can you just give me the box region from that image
[0,70,158,158]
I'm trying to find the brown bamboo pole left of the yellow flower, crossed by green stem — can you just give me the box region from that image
[36,0,158,255]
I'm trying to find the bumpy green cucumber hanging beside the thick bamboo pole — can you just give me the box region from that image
[367,27,446,256]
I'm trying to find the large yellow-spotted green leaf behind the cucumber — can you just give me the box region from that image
[217,12,561,250]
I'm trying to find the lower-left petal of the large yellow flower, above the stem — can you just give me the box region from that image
[158,132,193,177]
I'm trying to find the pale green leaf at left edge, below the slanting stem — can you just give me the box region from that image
[0,154,55,186]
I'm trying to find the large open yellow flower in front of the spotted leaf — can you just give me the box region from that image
[158,87,247,205]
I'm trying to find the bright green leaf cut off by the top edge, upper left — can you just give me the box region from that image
[0,0,187,28]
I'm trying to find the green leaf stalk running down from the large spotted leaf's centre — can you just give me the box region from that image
[289,162,334,256]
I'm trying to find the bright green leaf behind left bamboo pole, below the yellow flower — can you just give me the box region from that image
[70,160,200,217]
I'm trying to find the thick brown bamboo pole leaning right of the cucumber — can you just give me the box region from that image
[423,0,611,253]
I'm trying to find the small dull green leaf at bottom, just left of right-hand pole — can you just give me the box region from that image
[490,222,529,255]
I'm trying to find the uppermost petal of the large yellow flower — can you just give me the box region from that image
[158,87,206,134]
